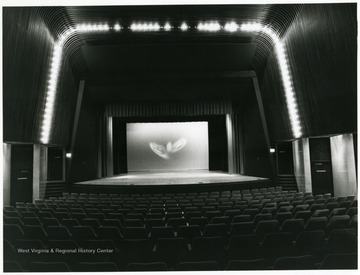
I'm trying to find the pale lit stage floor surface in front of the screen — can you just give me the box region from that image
[75,170,269,186]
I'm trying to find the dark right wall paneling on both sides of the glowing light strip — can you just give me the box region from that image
[257,4,357,140]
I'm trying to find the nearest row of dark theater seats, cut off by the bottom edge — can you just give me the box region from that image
[4,253,357,272]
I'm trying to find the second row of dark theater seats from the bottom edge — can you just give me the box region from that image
[4,229,357,269]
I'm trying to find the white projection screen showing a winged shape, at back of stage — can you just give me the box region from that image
[126,122,209,171]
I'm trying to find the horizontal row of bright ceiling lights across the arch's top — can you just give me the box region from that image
[75,22,248,32]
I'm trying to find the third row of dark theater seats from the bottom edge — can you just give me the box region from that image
[4,214,357,245]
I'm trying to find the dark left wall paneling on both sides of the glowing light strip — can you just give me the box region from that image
[3,7,78,145]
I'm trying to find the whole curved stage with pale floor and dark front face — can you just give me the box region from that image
[73,170,272,193]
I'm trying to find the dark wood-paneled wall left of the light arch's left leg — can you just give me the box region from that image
[3,8,53,142]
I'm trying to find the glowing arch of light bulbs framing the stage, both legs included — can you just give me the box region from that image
[40,22,303,144]
